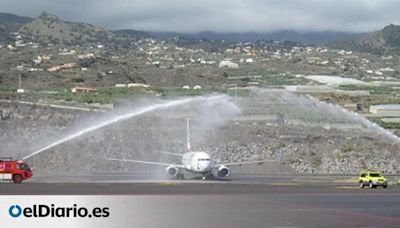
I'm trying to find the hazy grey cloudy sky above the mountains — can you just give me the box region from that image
[0,0,400,32]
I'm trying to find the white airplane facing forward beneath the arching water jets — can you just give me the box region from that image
[108,118,275,180]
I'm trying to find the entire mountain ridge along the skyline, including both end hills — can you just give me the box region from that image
[0,12,400,51]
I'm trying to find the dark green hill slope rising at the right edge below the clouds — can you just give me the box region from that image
[326,24,400,55]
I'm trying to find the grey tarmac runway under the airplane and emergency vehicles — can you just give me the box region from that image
[0,174,400,227]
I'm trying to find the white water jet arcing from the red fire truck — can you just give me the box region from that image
[22,95,227,160]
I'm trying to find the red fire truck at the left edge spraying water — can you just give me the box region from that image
[0,157,33,184]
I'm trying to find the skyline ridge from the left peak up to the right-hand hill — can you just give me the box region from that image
[0,12,364,45]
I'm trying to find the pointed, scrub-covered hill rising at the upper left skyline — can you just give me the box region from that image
[19,13,115,44]
